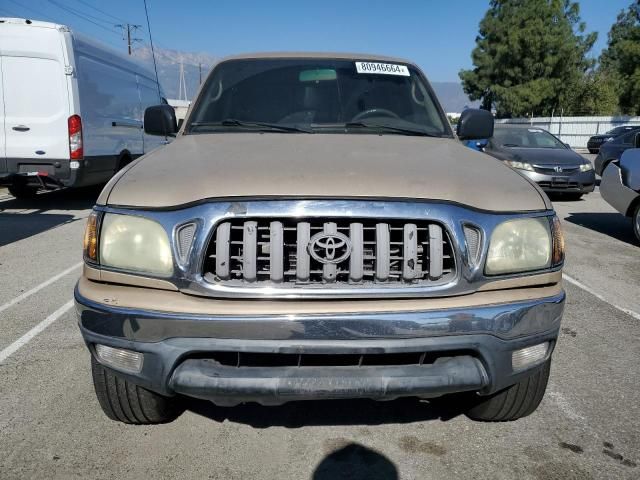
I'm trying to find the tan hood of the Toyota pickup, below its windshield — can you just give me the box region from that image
[98,133,550,211]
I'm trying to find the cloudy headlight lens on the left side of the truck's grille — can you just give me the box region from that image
[100,213,173,275]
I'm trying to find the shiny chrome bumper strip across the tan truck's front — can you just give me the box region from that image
[75,289,565,343]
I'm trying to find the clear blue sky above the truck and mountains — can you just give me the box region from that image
[0,0,632,81]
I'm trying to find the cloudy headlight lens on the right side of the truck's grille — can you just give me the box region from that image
[485,217,551,275]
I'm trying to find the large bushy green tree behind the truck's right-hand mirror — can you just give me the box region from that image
[460,0,597,117]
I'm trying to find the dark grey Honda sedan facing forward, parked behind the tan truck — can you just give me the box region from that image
[484,124,596,199]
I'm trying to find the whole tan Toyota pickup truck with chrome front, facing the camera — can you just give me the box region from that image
[75,53,565,424]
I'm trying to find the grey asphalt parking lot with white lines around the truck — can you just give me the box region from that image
[0,155,640,480]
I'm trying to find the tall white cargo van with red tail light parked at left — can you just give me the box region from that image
[0,18,166,197]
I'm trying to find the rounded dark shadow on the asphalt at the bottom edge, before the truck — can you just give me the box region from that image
[311,443,400,480]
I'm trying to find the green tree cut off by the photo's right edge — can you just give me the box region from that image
[600,0,640,115]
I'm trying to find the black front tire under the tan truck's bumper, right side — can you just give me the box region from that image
[465,360,551,422]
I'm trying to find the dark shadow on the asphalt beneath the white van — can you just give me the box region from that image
[0,187,101,247]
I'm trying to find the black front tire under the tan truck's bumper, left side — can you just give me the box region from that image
[91,356,184,425]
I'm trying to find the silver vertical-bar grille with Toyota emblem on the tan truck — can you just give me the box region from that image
[203,218,456,287]
